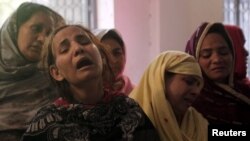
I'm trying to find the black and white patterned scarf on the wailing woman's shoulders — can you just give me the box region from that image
[23,94,148,141]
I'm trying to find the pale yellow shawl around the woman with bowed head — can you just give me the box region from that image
[129,51,208,141]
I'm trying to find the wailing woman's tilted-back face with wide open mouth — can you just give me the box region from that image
[50,26,102,86]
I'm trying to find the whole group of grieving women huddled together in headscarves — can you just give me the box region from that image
[0,2,250,141]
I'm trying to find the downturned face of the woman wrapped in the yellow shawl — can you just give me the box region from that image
[165,74,201,115]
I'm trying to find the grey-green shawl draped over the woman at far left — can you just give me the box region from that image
[0,2,64,131]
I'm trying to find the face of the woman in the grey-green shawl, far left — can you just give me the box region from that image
[17,11,52,62]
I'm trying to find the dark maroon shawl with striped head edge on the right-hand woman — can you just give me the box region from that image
[186,22,250,125]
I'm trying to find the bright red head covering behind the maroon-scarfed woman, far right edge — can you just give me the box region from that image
[225,25,248,80]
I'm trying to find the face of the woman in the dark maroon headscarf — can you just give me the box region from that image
[199,33,233,83]
